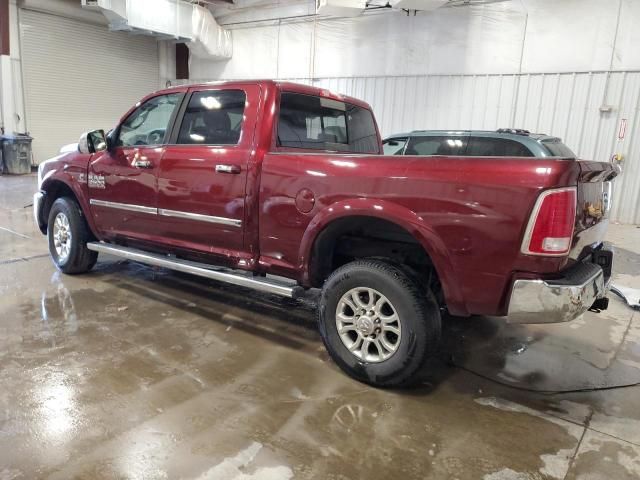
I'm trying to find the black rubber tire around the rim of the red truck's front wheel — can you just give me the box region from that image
[47,197,98,274]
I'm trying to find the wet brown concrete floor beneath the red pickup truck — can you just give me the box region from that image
[0,176,640,480]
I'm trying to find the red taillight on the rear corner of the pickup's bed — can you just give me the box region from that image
[521,187,577,256]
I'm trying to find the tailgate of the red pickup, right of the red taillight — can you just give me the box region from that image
[570,160,620,260]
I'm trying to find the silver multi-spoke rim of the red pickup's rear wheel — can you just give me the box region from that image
[336,287,402,363]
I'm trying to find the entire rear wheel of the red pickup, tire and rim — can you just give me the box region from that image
[318,260,440,387]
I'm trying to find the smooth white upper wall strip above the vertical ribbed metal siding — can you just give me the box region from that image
[192,0,640,78]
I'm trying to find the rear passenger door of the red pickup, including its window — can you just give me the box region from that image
[158,85,260,267]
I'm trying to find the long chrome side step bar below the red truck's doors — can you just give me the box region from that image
[87,242,304,298]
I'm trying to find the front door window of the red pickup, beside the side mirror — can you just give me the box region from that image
[116,93,182,147]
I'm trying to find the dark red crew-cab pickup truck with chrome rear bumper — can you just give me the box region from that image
[34,81,618,386]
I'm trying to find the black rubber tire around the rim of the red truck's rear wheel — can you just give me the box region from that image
[318,259,441,387]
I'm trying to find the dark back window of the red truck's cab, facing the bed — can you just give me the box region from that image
[278,92,379,153]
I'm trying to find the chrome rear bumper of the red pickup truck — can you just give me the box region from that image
[507,246,613,323]
